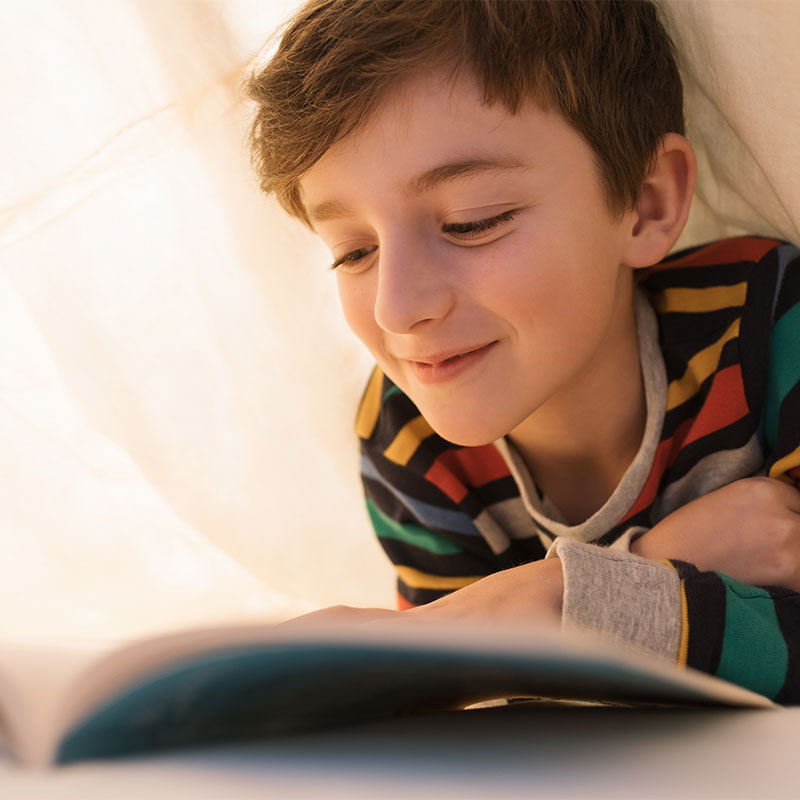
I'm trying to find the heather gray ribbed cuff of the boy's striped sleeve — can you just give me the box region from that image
[547,539,681,661]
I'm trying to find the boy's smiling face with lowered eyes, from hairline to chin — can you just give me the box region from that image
[301,68,635,445]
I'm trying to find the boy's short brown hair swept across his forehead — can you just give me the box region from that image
[246,0,684,226]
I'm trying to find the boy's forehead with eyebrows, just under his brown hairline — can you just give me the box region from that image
[300,71,587,222]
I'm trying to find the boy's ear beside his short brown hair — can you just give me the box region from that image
[624,133,697,267]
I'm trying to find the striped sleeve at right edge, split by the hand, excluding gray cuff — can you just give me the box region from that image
[672,244,800,704]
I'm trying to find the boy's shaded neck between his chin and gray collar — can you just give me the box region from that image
[509,286,647,525]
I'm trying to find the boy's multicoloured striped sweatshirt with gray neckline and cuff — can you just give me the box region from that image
[356,237,800,703]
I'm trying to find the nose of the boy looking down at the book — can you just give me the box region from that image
[374,236,455,333]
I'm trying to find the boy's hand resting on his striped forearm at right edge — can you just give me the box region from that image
[631,478,800,591]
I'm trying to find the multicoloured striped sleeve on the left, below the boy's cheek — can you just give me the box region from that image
[356,369,495,609]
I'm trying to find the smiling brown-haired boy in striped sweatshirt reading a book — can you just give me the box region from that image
[249,0,800,702]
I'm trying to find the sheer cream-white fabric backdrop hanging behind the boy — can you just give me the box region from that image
[0,0,800,638]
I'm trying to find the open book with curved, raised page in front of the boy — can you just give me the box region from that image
[0,620,772,765]
